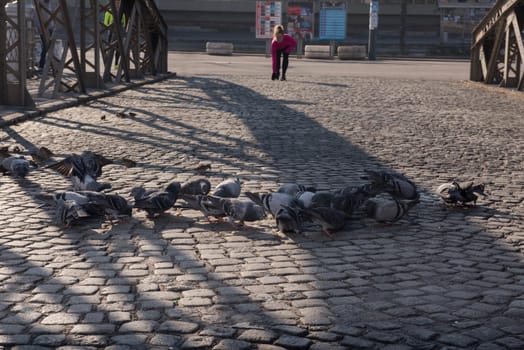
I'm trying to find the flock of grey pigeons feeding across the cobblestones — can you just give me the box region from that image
[0,147,486,236]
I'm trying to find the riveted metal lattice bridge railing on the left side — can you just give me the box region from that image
[0,0,168,106]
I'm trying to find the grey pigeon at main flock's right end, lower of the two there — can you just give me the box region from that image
[364,197,419,223]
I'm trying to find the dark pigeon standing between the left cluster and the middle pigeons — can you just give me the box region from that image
[131,182,180,217]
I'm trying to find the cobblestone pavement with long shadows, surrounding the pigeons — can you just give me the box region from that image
[0,56,524,350]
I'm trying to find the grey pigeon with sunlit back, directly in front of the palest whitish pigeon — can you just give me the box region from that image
[208,196,266,226]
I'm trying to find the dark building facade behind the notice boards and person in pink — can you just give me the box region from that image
[152,0,495,55]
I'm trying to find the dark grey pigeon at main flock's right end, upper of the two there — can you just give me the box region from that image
[362,170,419,200]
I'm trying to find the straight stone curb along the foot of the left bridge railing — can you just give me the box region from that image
[0,72,176,128]
